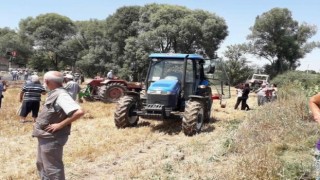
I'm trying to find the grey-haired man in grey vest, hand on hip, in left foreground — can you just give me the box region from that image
[32,71,84,180]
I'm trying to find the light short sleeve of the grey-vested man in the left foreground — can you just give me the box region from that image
[56,93,80,116]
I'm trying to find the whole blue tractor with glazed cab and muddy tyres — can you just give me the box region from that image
[114,53,215,136]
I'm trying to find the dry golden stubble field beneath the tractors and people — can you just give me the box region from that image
[0,81,317,180]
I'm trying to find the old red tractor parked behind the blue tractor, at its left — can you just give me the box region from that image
[80,78,142,103]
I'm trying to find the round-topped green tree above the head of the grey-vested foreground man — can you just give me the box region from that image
[19,13,75,69]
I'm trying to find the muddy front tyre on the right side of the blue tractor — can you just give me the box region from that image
[182,100,205,136]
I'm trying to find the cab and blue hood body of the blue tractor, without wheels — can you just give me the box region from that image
[146,54,207,111]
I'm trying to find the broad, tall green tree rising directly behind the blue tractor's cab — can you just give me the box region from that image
[119,4,228,80]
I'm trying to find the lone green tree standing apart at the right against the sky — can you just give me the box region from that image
[247,8,319,75]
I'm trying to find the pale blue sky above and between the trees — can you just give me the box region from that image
[0,0,320,72]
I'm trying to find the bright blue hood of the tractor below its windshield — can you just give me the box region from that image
[147,79,180,95]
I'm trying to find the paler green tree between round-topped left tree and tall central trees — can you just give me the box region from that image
[74,19,112,77]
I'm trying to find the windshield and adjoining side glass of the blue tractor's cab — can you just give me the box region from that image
[148,59,193,82]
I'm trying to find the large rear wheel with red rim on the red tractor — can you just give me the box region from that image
[99,83,127,103]
